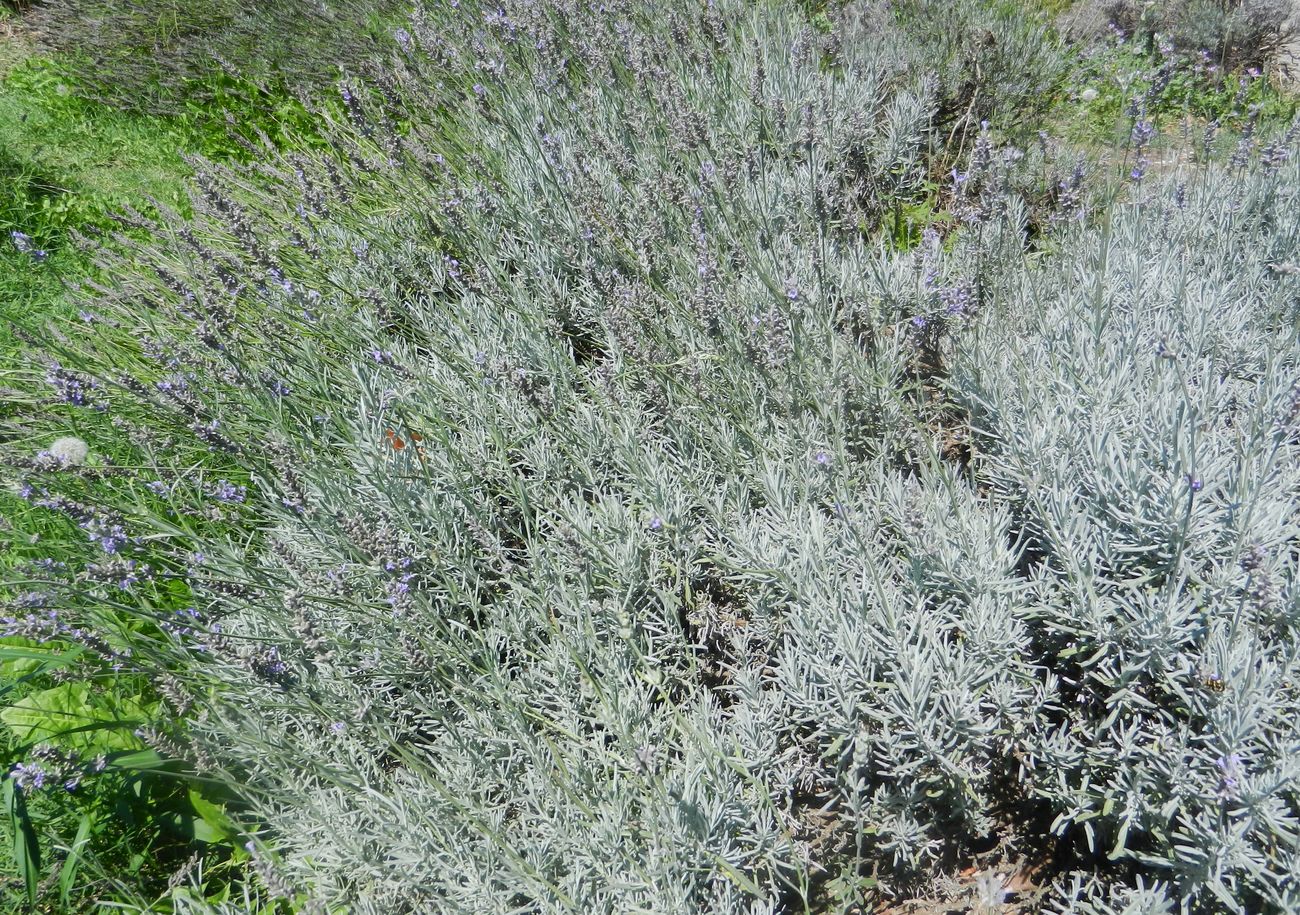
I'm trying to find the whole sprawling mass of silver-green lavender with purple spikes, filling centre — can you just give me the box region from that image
[7,0,1300,914]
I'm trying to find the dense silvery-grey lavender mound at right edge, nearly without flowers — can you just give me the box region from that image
[952,166,1300,911]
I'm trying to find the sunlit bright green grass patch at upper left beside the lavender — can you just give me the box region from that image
[0,47,335,361]
